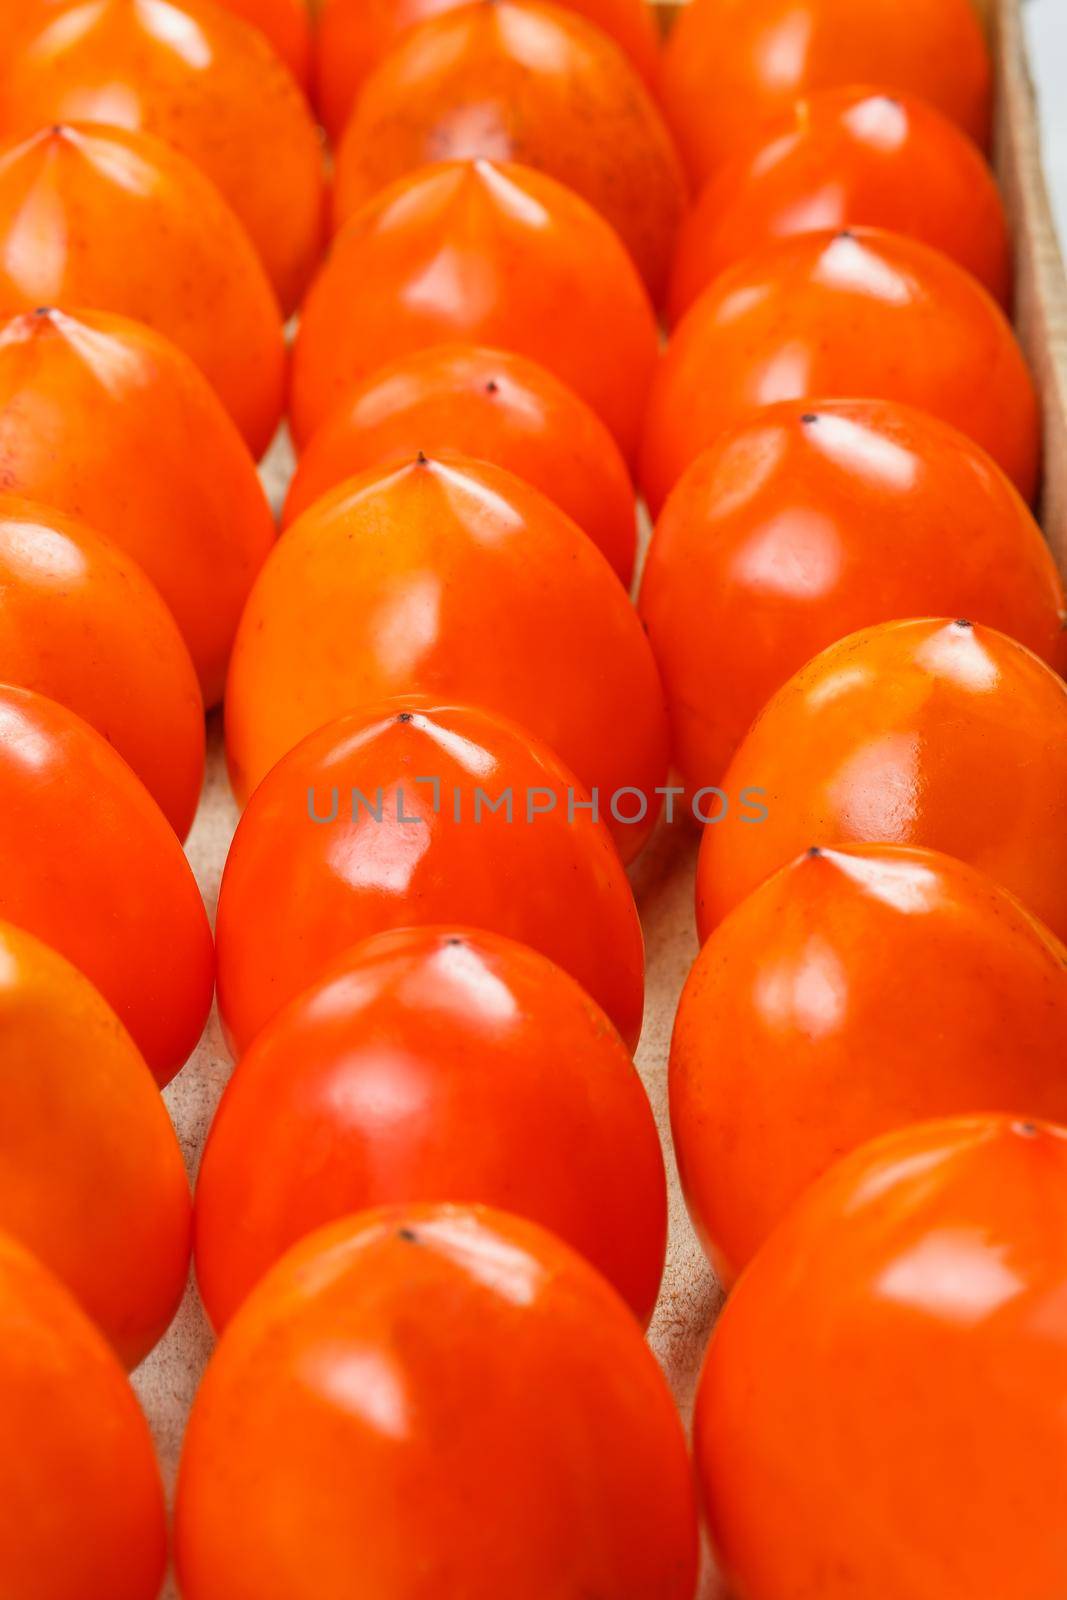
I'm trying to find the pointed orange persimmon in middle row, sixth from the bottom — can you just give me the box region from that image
[290,162,659,461]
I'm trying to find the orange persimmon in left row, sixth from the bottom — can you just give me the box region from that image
[0,125,285,454]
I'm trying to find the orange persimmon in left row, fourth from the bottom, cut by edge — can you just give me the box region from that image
[0,496,205,838]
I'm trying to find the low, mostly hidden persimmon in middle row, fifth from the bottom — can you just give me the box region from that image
[283,344,637,586]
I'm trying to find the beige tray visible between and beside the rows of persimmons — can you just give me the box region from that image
[134,0,1067,1600]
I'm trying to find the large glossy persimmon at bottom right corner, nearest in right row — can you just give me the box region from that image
[696,1117,1067,1600]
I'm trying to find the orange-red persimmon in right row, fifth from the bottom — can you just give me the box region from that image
[641,227,1040,514]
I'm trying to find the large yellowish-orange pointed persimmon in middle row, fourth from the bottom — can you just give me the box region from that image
[226,456,667,859]
